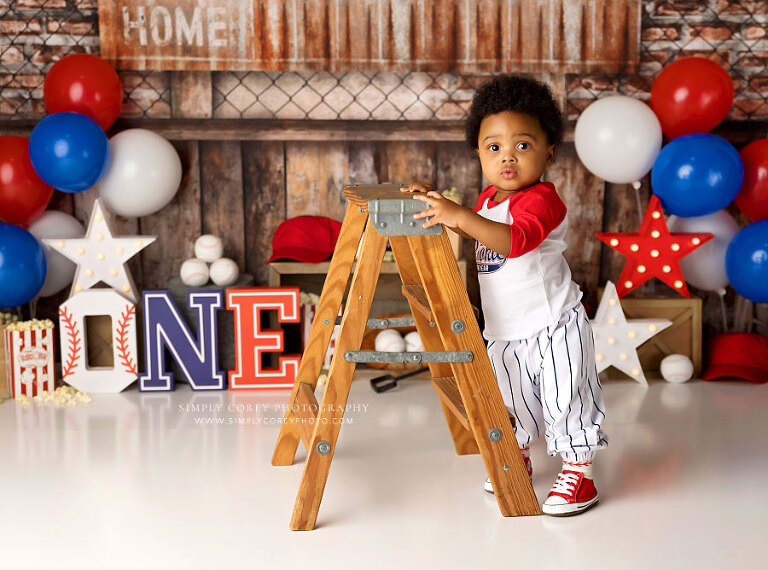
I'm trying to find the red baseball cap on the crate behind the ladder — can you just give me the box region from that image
[267,216,341,263]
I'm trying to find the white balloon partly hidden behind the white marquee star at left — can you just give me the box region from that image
[29,210,85,297]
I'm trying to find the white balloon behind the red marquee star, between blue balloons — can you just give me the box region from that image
[667,210,739,291]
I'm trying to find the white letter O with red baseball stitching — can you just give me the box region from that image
[59,289,138,394]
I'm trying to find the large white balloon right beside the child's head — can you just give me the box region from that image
[574,95,662,184]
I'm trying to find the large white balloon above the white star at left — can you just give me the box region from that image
[97,129,181,218]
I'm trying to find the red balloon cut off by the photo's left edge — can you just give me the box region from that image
[0,135,53,226]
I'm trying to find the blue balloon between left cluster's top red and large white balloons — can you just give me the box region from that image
[29,112,109,192]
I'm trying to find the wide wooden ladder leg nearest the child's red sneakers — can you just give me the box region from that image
[407,232,541,516]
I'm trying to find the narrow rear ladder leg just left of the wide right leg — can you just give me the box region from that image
[389,237,480,455]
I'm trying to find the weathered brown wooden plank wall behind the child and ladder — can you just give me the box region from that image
[27,51,768,329]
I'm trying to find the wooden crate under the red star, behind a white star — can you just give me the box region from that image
[605,297,702,378]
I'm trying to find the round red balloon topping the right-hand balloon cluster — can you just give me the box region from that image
[651,57,733,139]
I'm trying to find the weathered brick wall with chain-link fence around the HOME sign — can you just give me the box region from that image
[0,0,768,120]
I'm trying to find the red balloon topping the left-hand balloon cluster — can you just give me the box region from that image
[43,53,123,131]
